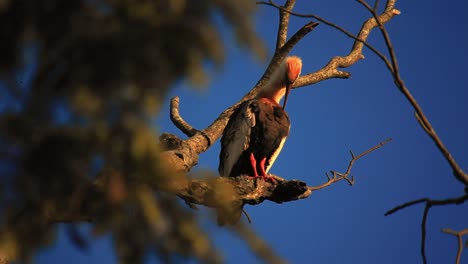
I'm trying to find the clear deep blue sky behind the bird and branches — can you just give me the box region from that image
[36,0,468,264]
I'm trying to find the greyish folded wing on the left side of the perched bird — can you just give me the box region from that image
[218,101,255,176]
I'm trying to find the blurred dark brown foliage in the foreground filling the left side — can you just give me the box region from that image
[0,0,265,263]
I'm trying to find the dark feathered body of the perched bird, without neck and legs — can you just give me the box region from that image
[218,98,290,177]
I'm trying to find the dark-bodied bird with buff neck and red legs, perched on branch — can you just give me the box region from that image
[218,56,302,183]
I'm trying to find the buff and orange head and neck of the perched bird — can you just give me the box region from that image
[258,56,302,109]
